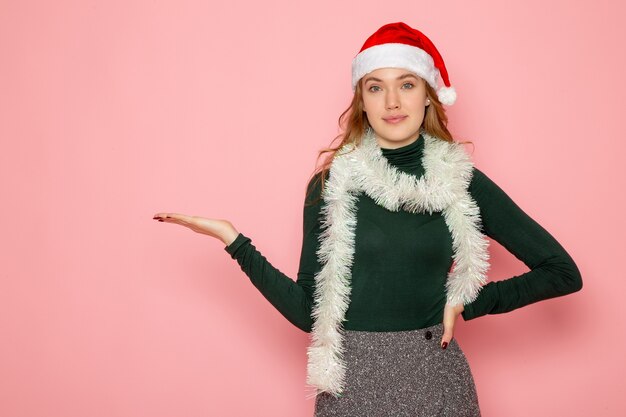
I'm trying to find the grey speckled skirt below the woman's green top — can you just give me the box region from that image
[315,323,480,417]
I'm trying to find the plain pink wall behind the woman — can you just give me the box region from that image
[0,0,626,417]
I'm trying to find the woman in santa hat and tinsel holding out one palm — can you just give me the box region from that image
[154,22,582,417]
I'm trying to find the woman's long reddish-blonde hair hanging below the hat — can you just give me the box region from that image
[307,78,472,204]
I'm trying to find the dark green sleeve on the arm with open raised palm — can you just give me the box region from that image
[224,173,322,333]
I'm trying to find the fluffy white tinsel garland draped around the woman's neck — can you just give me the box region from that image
[307,128,489,396]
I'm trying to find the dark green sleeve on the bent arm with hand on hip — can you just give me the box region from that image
[461,168,582,320]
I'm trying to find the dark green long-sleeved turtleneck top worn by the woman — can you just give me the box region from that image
[224,136,582,332]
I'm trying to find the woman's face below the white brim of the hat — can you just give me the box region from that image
[362,68,427,149]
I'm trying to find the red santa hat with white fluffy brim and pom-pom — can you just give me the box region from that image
[352,22,456,106]
